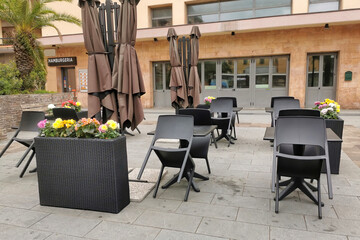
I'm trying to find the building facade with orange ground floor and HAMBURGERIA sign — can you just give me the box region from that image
[2,0,360,109]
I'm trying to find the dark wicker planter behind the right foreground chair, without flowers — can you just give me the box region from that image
[321,118,344,174]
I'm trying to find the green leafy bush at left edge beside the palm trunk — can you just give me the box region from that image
[0,62,22,95]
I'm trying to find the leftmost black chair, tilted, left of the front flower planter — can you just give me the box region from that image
[0,111,45,177]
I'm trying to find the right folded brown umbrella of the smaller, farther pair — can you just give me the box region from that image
[188,26,201,107]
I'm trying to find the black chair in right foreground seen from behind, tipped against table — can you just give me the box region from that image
[272,116,329,219]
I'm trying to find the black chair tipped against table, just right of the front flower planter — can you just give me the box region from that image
[138,115,195,201]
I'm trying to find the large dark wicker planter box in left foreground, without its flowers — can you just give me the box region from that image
[35,137,130,213]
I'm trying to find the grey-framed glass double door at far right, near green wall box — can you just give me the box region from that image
[305,53,337,107]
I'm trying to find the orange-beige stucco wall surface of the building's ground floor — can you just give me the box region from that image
[48,24,360,108]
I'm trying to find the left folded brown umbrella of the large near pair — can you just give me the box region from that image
[79,0,118,121]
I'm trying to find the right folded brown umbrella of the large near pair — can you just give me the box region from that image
[112,0,145,130]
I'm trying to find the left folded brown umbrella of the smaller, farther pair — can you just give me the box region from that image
[167,28,188,109]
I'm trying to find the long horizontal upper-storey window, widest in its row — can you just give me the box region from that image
[187,0,291,24]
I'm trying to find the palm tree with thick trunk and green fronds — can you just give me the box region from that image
[0,0,80,88]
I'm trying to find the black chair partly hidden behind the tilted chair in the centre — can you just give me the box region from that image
[179,108,216,173]
